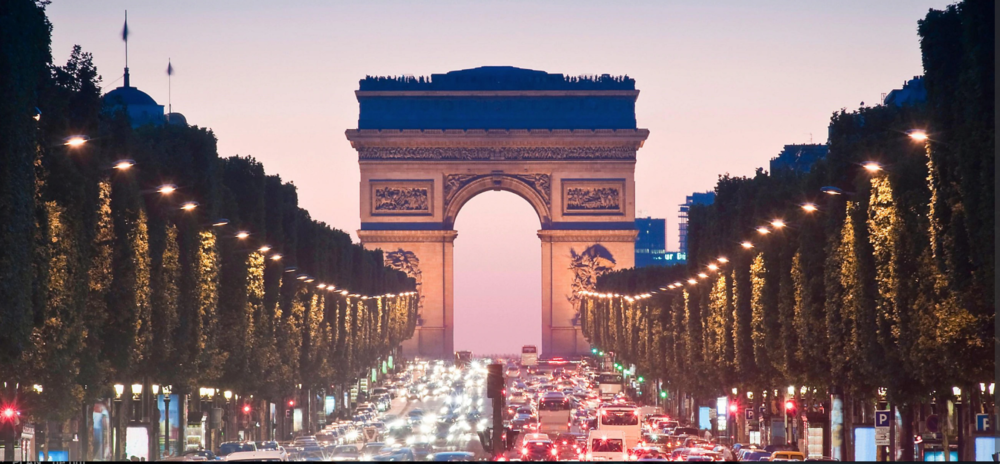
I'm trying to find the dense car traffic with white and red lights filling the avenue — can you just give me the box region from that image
[206,346,805,461]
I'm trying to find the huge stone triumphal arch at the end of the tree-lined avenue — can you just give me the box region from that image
[347,67,649,357]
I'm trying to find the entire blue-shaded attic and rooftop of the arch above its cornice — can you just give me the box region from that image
[355,66,639,130]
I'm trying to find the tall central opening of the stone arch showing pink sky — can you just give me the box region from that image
[454,189,542,355]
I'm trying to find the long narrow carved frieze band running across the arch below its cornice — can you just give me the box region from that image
[358,147,635,161]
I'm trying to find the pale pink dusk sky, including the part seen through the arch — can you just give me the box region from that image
[48,0,950,354]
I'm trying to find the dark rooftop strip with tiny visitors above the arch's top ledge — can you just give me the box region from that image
[360,66,635,92]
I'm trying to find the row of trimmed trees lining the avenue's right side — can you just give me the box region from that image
[582,2,996,460]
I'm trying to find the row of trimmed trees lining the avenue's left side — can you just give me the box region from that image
[0,1,417,430]
